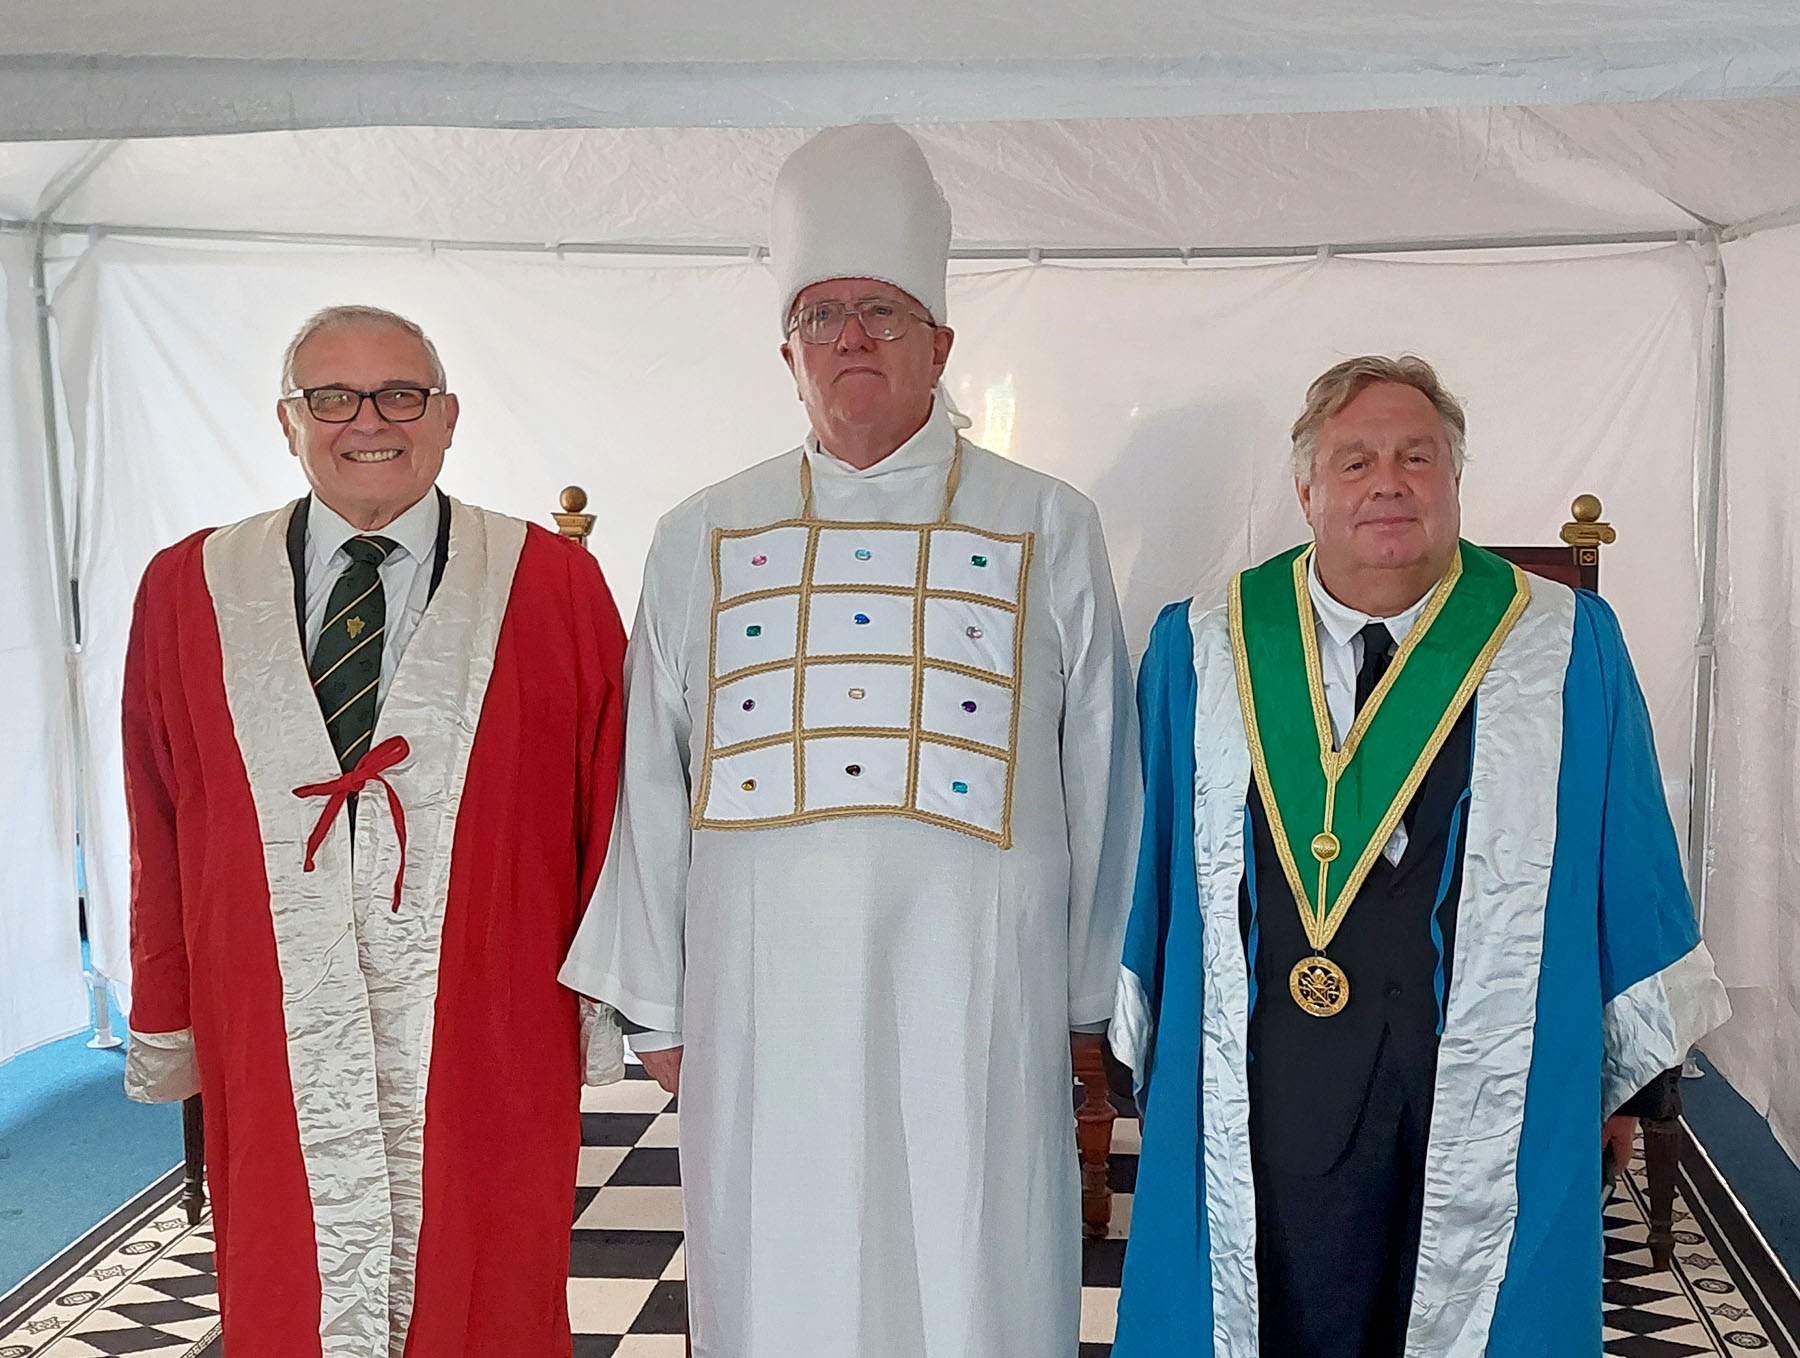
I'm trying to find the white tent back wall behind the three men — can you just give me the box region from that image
[56,238,1706,1008]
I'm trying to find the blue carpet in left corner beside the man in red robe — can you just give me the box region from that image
[0,1010,182,1295]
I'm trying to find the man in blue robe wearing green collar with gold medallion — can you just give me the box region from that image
[1112,358,1728,1358]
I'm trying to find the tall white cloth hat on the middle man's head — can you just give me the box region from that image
[769,122,950,331]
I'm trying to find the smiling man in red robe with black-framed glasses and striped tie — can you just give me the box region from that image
[124,308,625,1358]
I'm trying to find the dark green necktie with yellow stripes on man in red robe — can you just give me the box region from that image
[310,537,400,773]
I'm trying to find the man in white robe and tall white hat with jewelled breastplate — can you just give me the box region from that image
[562,126,1139,1358]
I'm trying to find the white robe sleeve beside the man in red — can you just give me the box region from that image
[560,521,700,1032]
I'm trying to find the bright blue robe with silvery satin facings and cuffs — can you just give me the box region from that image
[1112,580,1728,1358]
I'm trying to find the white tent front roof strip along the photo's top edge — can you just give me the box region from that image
[0,0,1800,139]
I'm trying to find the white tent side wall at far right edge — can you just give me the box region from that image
[1706,227,1800,1160]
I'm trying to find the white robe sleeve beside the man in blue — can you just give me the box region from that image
[1048,497,1143,1027]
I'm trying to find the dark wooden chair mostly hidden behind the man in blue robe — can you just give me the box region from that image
[1075,495,1681,1268]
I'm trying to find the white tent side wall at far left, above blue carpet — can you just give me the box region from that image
[0,236,86,1061]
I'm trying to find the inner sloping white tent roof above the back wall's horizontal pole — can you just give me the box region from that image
[0,99,1800,249]
